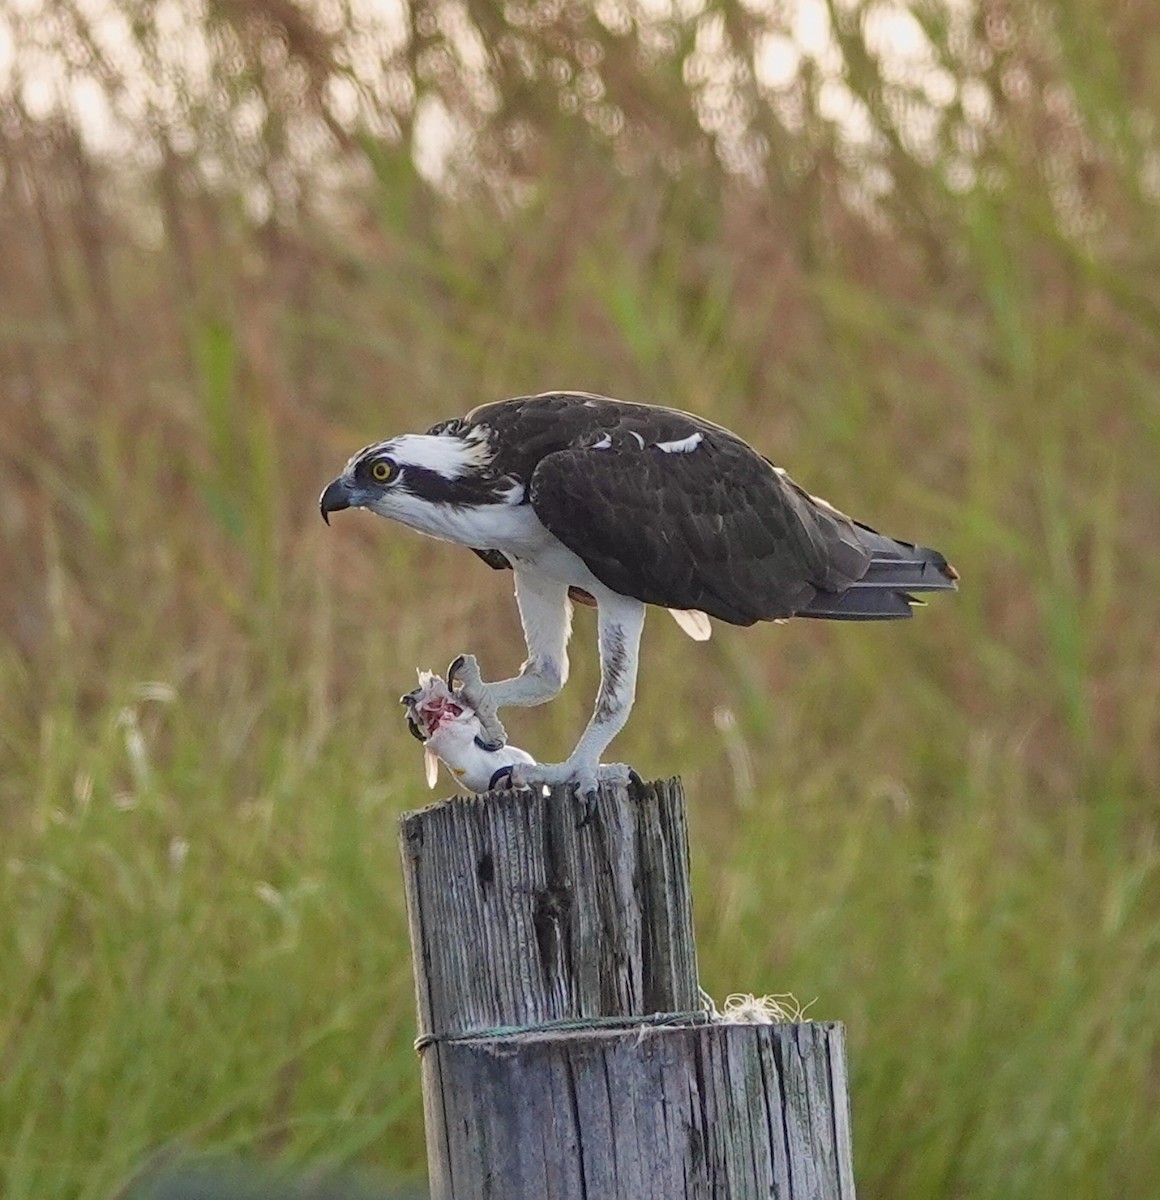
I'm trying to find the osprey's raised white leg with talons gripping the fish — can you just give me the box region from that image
[447,570,572,749]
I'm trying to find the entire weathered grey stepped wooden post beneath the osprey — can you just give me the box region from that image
[401,780,854,1200]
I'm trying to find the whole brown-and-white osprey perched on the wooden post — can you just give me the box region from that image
[319,392,958,797]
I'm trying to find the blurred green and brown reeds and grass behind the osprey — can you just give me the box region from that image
[0,0,1160,1200]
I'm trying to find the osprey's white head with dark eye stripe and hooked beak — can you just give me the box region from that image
[318,430,512,528]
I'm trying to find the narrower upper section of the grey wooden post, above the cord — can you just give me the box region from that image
[401,780,701,1037]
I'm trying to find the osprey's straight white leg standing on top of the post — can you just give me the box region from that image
[512,590,644,796]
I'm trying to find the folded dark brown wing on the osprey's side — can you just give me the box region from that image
[529,425,870,625]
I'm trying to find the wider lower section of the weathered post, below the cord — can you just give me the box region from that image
[423,1021,854,1200]
